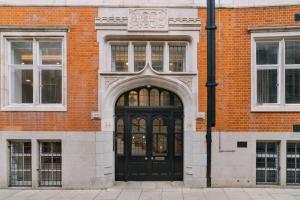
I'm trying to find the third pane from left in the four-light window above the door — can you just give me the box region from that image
[151,44,164,71]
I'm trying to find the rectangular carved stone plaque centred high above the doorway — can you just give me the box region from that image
[128,8,169,31]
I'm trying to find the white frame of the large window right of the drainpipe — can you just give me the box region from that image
[251,32,300,112]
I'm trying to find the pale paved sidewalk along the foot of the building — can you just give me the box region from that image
[0,182,300,200]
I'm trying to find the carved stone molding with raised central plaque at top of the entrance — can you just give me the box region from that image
[96,8,201,32]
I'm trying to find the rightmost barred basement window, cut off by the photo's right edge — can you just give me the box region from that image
[286,142,300,184]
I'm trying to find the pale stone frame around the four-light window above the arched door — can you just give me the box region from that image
[106,40,190,74]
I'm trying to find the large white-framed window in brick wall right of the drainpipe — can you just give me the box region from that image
[252,34,300,111]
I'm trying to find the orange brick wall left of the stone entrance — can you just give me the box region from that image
[0,7,100,131]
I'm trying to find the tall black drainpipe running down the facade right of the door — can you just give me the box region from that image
[206,0,217,187]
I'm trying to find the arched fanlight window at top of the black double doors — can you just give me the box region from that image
[116,87,183,109]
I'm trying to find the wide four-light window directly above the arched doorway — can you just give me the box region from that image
[110,41,187,73]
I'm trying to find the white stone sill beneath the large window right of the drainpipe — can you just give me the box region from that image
[251,104,300,112]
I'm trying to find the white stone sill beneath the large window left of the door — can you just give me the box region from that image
[0,104,67,112]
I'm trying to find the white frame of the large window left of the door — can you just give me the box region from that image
[0,32,67,111]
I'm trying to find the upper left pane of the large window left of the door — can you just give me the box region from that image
[11,41,33,65]
